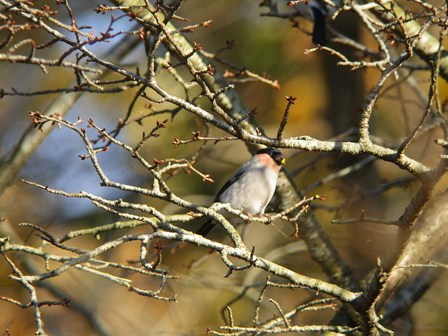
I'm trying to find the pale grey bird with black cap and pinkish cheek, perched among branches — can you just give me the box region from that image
[196,147,286,237]
